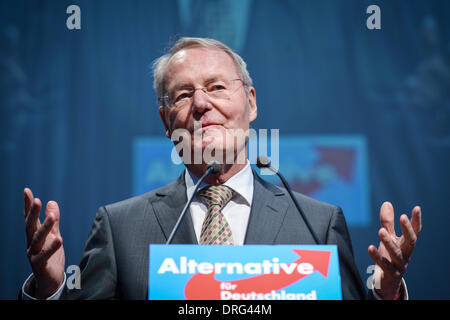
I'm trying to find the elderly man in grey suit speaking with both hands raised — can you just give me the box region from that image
[22,38,421,299]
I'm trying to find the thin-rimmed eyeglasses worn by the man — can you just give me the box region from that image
[163,79,242,108]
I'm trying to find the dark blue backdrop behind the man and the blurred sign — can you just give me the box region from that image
[0,0,450,299]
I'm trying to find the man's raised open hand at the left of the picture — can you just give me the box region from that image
[24,188,65,299]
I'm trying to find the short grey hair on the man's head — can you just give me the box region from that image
[152,37,253,105]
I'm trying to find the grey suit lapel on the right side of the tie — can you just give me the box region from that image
[244,171,289,244]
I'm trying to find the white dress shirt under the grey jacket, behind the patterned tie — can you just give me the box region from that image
[184,161,253,245]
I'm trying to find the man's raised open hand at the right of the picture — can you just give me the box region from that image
[368,202,422,299]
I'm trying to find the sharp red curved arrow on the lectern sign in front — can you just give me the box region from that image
[184,249,331,300]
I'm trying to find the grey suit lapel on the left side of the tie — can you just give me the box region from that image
[151,172,197,244]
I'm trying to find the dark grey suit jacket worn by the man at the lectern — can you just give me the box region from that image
[61,172,366,299]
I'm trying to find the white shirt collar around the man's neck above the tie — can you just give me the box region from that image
[184,160,253,206]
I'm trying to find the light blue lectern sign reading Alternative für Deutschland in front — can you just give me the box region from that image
[148,245,342,300]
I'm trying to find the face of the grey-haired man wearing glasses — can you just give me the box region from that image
[159,48,257,165]
